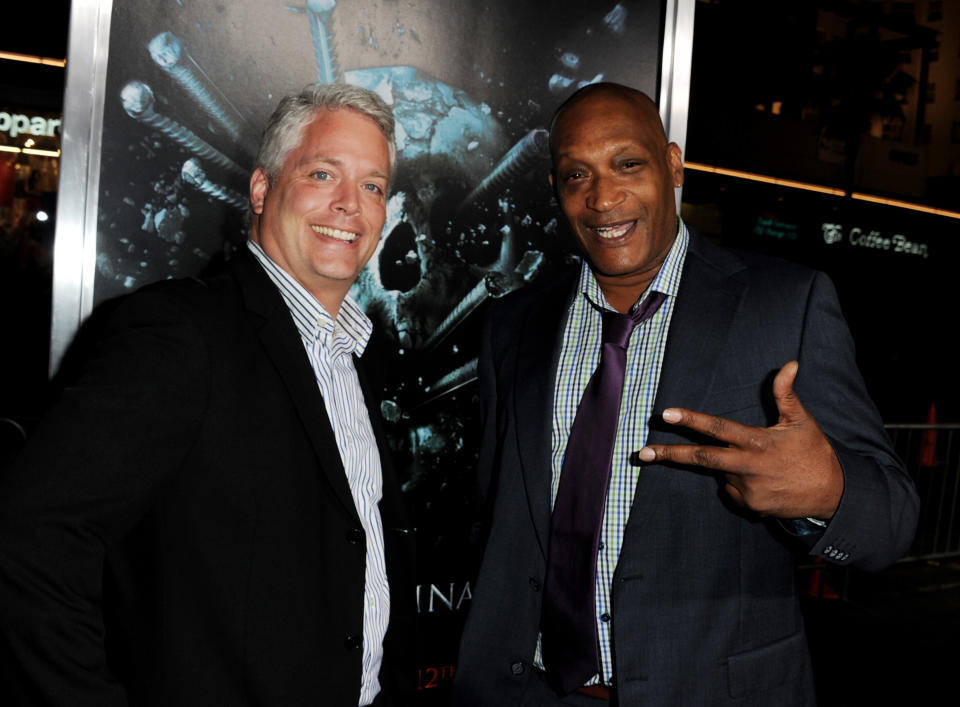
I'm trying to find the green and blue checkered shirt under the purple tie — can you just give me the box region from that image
[535,222,689,685]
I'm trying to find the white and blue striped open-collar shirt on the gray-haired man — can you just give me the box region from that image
[247,241,390,705]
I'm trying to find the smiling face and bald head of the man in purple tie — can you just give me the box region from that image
[550,87,683,311]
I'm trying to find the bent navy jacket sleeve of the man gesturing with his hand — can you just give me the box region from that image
[796,273,919,570]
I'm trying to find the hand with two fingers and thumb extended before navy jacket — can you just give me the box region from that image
[640,361,843,520]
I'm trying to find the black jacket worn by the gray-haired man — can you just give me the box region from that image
[0,249,413,707]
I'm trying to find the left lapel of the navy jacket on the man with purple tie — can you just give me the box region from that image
[513,268,579,557]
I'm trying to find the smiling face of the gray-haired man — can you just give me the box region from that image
[250,109,390,317]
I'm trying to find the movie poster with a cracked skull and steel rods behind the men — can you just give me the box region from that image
[80,0,664,704]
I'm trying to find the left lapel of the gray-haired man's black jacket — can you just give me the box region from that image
[231,248,360,524]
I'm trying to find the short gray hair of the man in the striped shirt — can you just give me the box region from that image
[255,83,397,184]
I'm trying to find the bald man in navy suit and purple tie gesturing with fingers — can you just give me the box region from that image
[454,84,917,707]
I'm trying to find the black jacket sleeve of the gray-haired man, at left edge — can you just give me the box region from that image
[0,292,209,707]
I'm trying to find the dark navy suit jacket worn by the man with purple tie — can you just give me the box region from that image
[454,234,918,707]
